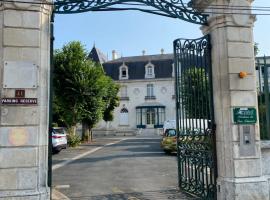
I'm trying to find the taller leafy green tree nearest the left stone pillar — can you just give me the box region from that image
[54,42,87,134]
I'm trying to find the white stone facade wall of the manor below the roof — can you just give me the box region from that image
[97,78,176,130]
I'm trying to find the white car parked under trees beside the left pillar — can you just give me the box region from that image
[52,127,67,153]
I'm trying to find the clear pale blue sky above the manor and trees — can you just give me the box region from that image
[55,0,270,58]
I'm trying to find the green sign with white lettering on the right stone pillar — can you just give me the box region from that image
[233,108,257,124]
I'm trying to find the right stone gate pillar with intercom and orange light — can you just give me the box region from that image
[194,0,269,200]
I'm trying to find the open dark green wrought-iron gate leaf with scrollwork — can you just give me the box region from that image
[174,35,217,199]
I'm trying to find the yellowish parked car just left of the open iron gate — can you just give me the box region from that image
[160,129,177,153]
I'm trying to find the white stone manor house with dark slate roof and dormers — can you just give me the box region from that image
[89,47,176,133]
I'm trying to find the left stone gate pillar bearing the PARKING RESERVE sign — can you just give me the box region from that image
[0,0,51,200]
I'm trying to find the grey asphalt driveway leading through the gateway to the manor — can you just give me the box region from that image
[53,137,192,200]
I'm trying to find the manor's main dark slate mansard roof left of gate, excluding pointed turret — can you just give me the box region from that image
[103,54,173,80]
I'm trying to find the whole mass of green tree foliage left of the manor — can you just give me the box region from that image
[53,42,119,138]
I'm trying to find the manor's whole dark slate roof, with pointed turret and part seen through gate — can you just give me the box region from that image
[89,47,207,80]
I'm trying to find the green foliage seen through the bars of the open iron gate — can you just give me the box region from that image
[180,67,209,119]
